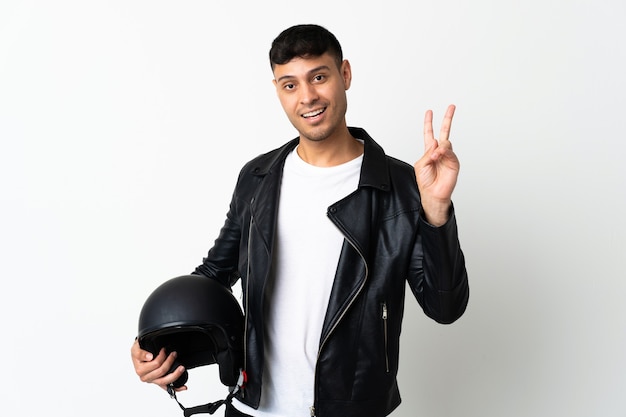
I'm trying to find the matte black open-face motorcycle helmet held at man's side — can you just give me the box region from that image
[137,275,244,386]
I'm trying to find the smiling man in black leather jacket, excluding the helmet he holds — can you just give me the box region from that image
[131,25,469,417]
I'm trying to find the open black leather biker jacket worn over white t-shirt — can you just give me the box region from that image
[196,128,469,417]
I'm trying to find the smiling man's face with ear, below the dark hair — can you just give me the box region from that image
[274,53,352,141]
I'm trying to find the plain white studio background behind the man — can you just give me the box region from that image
[0,0,626,417]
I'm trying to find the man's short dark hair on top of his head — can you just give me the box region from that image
[270,25,343,70]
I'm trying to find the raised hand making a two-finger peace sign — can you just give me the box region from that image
[414,104,460,226]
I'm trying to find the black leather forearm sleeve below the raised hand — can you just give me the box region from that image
[409,203,469,324]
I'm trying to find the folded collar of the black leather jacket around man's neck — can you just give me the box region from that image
[253,127,390,191]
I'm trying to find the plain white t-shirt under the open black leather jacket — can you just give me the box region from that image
[233,145,363,417]
